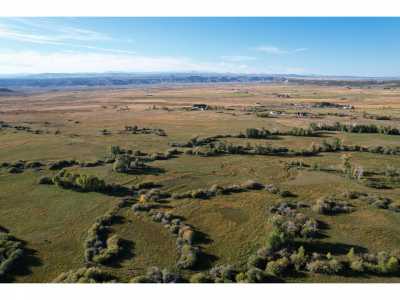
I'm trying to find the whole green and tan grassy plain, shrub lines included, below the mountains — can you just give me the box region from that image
[0,84,400,282]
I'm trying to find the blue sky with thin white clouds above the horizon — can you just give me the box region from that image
[0,17,400,76]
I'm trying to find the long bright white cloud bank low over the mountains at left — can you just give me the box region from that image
[0,51,268,74]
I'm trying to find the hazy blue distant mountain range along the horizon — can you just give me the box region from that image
[0,73,400,92]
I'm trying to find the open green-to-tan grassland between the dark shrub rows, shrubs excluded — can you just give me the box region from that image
[0,84,400,282]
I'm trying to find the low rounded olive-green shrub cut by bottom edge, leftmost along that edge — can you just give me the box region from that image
[53,267,113,283]
